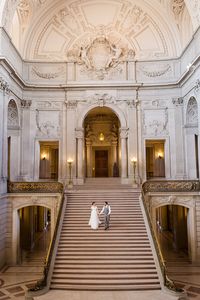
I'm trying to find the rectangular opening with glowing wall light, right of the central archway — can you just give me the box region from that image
[146,140,165,179]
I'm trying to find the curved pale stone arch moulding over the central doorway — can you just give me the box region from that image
[77,103,127,128]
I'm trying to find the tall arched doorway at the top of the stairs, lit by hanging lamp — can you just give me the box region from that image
[84,107,121,177]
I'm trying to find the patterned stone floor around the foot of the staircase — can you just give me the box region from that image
[0,225,200,300]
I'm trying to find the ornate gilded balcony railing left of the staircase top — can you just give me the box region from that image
[8,182,63,193]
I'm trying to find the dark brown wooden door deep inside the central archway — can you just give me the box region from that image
[95,150,108,177]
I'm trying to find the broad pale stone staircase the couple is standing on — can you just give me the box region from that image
[51,178,161,291]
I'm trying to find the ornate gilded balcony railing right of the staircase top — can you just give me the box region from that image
[142,180,200,193]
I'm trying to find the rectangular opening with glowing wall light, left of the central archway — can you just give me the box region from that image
[39,141,59,180]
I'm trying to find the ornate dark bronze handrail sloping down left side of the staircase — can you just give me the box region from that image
[28,194,66,293]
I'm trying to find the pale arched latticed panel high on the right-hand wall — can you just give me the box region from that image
[186,96,198,126]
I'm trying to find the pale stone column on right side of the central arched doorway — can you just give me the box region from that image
[120,128,128,179]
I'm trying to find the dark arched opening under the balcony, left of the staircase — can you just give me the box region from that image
[17,205,51,263]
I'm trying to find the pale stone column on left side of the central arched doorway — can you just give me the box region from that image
[76,128,83,184]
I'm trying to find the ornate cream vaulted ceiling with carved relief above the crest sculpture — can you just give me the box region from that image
[0,0,200,61]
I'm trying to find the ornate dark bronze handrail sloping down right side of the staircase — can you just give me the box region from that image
[142,182,184,293]
